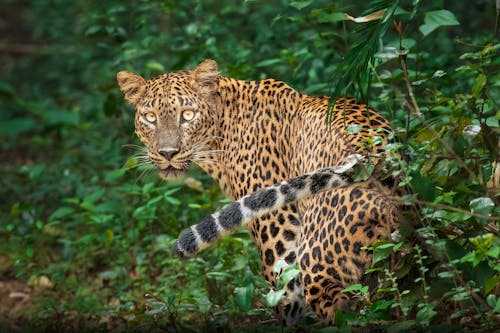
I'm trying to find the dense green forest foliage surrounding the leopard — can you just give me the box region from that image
[0,0,500,331]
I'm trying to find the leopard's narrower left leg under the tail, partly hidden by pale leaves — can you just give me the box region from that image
[248,204,307,326]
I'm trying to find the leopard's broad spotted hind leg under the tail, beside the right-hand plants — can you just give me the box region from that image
[299,186,395,322]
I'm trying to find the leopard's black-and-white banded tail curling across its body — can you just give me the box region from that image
[174,154,362,258]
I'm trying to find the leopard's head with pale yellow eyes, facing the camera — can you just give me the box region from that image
[116,60,219,179]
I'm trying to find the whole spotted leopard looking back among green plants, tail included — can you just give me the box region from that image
[116,59,398,326]
